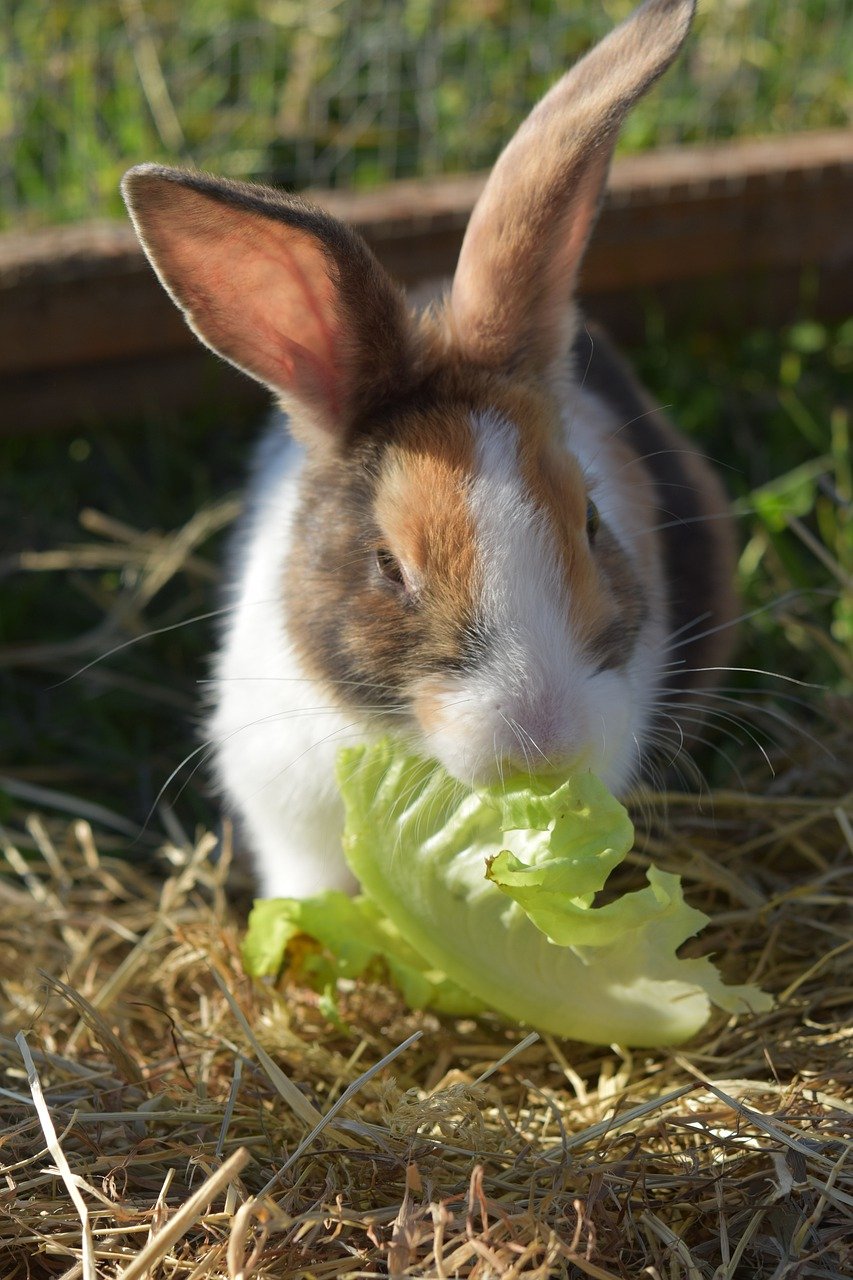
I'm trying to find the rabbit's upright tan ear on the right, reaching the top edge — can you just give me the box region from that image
[451,0,695,372]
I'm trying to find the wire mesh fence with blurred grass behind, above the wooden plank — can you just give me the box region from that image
[0,0,853,227]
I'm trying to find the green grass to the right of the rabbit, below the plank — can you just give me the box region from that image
[635,320,853,692]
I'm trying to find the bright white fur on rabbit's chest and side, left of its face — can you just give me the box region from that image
[209,435,364,897]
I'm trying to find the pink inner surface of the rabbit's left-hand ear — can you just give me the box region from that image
[145,184,346,417]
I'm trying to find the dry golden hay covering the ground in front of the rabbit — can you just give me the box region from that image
[0,707,853,1280]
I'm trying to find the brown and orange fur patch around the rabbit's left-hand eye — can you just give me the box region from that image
[286,369,491,727]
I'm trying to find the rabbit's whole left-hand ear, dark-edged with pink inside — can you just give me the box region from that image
[122,165,409,443]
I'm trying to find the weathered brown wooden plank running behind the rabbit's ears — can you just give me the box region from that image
[0,132,853,430]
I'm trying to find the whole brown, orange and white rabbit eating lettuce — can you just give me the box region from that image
[123,0,733,896]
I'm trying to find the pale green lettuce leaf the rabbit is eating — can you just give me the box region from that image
[243,741,771,1046]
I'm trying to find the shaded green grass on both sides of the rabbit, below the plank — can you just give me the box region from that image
[0,320,853,832]
